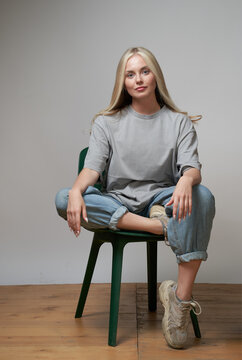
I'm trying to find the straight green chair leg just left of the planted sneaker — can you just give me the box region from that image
[147,241,157,311]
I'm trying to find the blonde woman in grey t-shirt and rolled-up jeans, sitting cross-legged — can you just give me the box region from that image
[56,47,215,348]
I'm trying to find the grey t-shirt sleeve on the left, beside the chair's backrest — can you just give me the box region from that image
[84,117,110,174]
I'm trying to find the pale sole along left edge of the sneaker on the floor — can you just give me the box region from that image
[159,280,184,349]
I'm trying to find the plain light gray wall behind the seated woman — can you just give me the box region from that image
[0,0,242,284]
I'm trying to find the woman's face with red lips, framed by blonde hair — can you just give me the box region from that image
[124,54,156,100]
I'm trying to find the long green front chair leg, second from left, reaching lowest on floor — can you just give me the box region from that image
[108,238,126,346]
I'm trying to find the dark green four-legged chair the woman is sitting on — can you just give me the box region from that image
[75,148,201,346]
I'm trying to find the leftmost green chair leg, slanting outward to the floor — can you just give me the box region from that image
[75,234,103,318]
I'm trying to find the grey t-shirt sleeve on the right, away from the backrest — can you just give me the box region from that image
[177,116,202,176]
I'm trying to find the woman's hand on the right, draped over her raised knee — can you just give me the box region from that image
[166,176,193,223]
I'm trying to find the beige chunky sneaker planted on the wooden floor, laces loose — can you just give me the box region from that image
[159,280,202,349]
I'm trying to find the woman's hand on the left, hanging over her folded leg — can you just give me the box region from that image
[67,189,88,237]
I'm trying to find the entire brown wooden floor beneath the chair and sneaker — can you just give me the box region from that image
[0,284,242,360]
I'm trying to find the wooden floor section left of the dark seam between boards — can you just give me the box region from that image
[0,284,138,360]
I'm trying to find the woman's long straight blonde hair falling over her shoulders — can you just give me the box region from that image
[93,47,202,122]
